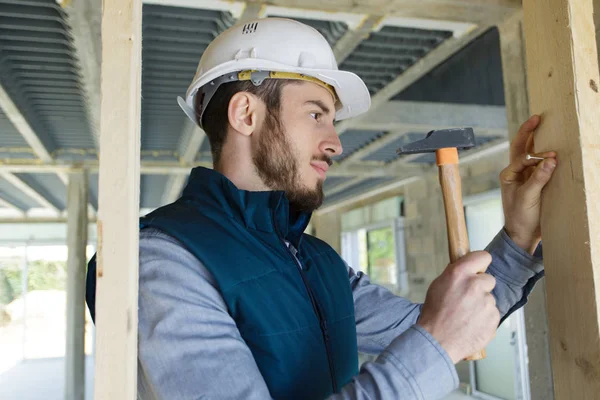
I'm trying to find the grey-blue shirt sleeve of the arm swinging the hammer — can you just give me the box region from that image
[138,229,458,400]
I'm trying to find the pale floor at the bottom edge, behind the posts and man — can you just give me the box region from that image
[0,357,472,400]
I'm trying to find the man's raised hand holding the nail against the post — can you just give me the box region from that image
[500,115,556,254]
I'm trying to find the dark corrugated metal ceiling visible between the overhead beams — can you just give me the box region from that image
[0,0,504,209]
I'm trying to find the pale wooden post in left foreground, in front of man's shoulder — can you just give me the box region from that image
[94,0,142,400]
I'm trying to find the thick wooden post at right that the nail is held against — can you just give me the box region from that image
[523,0,600,400]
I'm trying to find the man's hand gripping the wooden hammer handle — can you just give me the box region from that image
[417,251,500,364]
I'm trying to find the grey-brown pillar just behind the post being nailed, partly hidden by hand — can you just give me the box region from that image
[498,13,554,400]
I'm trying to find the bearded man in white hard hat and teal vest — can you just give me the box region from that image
[88,18,556,399]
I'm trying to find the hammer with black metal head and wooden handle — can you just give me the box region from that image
[397,128,485,360]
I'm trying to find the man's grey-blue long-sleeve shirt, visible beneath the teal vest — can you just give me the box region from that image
[138,229,543,400]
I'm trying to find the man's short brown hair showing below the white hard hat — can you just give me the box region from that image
[194,79,294,164]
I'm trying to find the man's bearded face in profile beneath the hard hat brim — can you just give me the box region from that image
[253,82,342,211]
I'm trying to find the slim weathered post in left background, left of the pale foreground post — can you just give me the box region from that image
[65,171,88,400]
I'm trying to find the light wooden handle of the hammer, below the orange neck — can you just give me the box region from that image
[439,163,486,361]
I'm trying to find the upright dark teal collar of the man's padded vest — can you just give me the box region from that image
[182,167,311,248]
